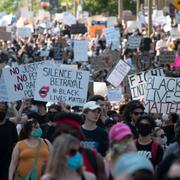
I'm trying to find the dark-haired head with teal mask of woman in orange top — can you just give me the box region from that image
[19,119,42,140]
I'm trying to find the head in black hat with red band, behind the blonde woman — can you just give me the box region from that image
[54,112,84,140]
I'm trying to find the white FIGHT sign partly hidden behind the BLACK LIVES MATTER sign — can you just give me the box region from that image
[128,68,164,100]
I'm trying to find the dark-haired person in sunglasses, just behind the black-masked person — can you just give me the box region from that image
[123,100,145,139]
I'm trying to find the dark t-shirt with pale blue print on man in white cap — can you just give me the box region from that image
[81,127,109,156]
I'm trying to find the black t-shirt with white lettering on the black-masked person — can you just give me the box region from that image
[136,141,163,166]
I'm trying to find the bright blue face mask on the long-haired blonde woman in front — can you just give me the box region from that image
[67,152,83,170]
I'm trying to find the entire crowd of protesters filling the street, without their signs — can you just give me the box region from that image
[0,5,180,180]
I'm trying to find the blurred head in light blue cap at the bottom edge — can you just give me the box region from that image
[114,152,154,180]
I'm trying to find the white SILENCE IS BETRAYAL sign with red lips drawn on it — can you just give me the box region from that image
[34,66,89,106]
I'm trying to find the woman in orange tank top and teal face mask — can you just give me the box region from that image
[9,120,52,180]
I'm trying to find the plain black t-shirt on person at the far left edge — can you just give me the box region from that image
[0,120,18,179]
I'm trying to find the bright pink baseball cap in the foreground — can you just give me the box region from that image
[109,123,133,141]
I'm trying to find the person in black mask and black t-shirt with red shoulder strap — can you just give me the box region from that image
[136,115,163,167]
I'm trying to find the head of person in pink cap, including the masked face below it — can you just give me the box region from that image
[109,123,136,159]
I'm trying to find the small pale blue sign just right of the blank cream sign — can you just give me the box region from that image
[107,88,122,102]
